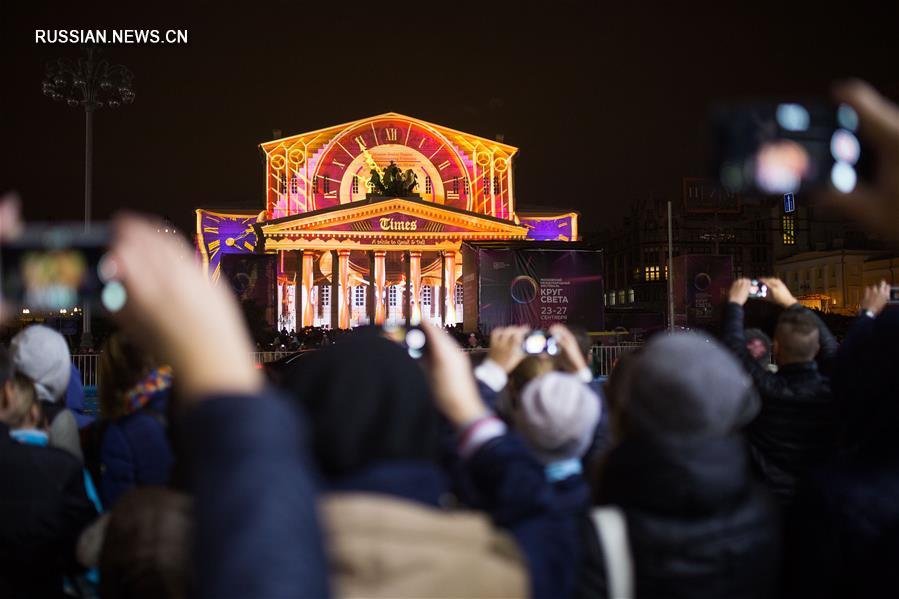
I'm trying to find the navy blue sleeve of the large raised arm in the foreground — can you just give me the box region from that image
[180,392,330,598]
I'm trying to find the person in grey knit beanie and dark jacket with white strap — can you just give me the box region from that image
[578,334,780,599]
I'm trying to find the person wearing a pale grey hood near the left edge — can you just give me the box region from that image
[10,325,84,461]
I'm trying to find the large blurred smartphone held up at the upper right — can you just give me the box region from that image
[711,102,870,194]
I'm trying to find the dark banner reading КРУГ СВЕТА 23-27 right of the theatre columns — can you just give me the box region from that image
[478,248,605,332]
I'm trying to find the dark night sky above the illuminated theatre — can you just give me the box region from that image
[0,0,899,237]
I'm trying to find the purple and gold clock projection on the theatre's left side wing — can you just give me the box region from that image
[197,209,259,281]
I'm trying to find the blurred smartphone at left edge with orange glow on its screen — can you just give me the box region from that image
[0,224,124,311]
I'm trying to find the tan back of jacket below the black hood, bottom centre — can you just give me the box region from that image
[320,493,528,598]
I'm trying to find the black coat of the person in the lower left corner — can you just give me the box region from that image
[0,423,97,597]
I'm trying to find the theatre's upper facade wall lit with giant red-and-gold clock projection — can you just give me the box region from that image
[266,113,513,219]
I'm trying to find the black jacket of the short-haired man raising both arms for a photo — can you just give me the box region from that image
[724,302,840,506]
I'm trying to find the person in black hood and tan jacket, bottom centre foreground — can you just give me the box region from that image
[285,329,528,597]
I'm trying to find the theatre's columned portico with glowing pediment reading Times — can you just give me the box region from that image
[257,198,527,329]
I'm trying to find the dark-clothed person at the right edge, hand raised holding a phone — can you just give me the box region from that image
[789,283,899,599]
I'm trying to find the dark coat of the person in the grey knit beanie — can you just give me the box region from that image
[578,438,780,599]
